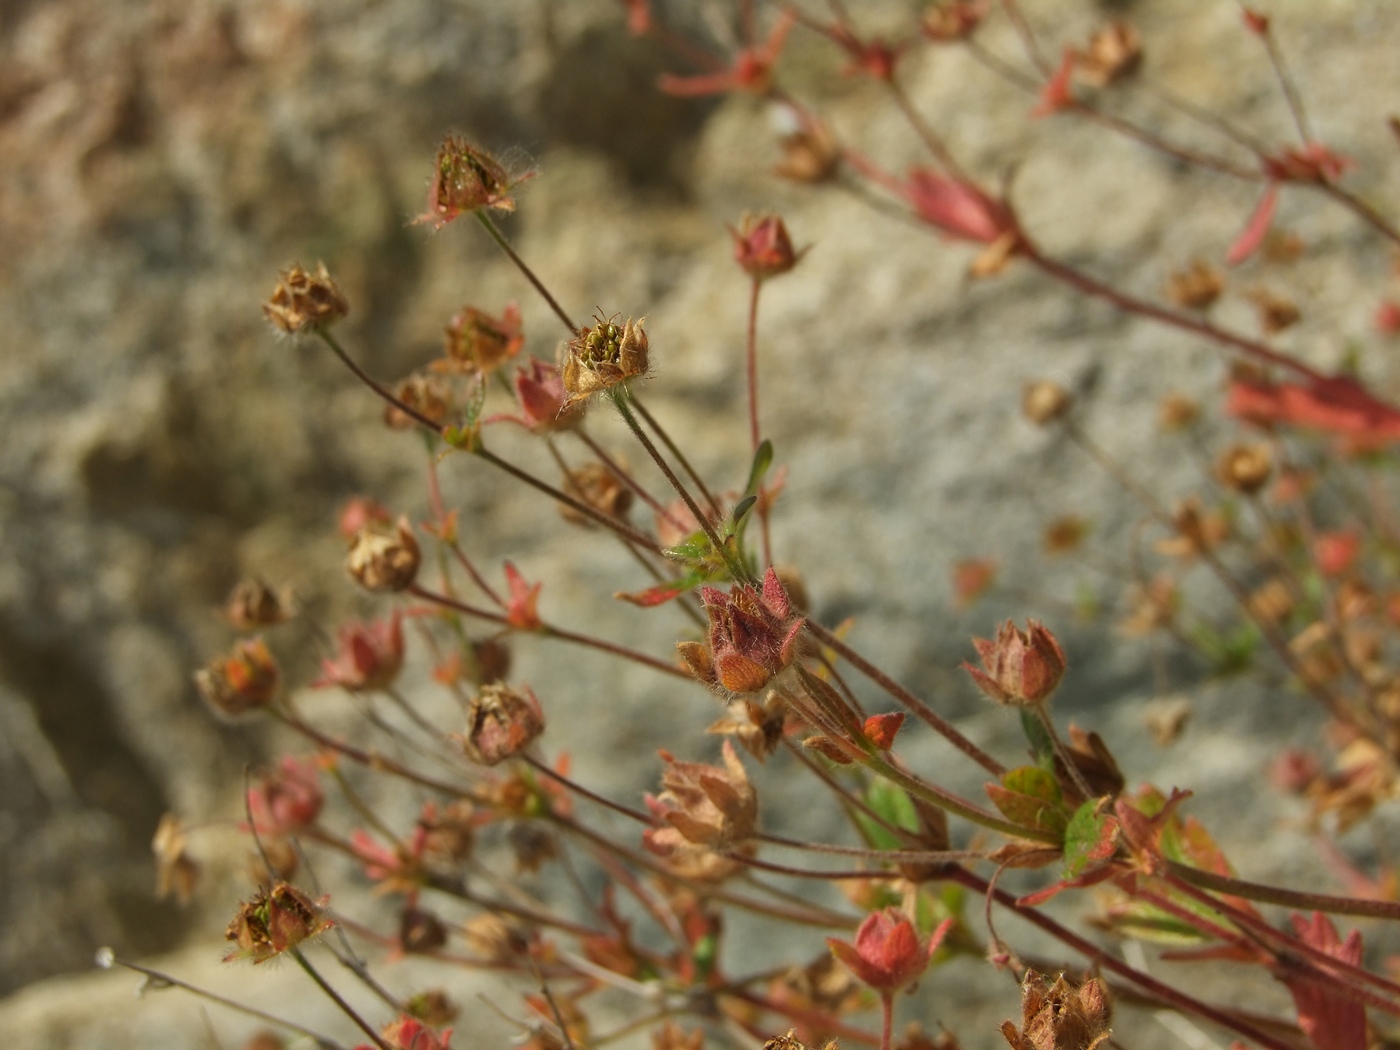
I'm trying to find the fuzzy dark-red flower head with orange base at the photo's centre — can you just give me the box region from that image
[678,568,804,693]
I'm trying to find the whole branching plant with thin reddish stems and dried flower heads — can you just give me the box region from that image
[101,0,1400,1050]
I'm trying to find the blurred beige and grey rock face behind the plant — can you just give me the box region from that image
[0,0,1400,1047]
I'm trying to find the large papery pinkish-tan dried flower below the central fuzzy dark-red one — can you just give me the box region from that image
[643,741,759,873]
